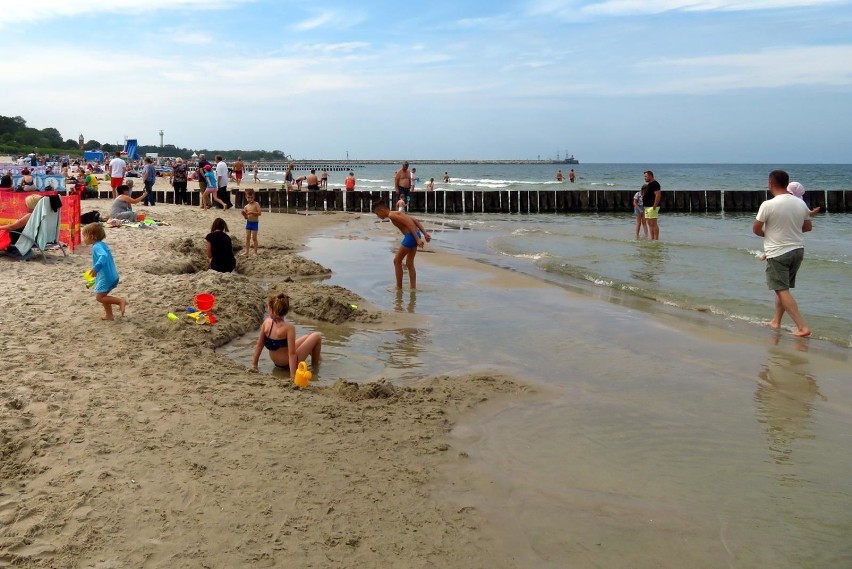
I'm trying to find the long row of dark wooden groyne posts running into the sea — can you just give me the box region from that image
[95,188,852,214]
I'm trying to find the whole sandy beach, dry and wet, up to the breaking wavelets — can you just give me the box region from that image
[0,175,852,568]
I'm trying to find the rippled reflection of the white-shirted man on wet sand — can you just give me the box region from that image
[754,335,825,464]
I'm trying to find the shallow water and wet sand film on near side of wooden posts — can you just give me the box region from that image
[290,203,852,568]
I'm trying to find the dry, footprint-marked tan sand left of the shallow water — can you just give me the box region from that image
[0,182,532,568]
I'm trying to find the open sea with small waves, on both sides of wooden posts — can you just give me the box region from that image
[262,163,852,348]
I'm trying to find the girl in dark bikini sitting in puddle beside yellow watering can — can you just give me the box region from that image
[251,292,322,378]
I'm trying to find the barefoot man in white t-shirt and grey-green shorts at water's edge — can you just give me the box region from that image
[752,170,812,337]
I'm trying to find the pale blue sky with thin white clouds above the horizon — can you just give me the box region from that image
[6,0,852,164]
